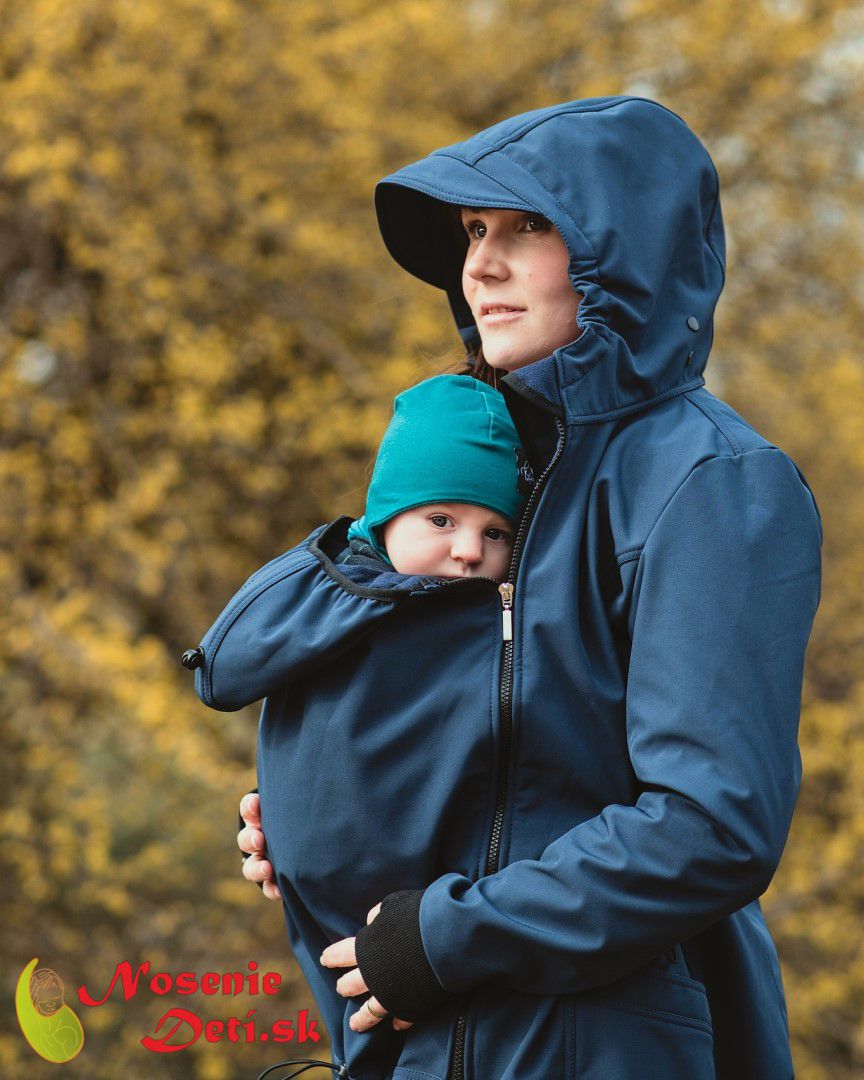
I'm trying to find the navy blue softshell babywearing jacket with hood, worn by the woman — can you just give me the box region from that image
[189,97,822,1080]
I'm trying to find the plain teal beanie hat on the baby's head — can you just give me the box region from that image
[348,375,525,566]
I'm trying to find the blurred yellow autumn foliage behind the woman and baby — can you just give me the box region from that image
[0,0,864,1080]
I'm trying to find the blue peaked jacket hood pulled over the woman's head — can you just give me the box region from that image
[375,96,726,422]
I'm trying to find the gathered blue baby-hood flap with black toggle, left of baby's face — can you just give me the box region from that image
[190,526,394,712]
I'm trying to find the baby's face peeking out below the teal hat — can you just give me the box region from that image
[379,502,515,581]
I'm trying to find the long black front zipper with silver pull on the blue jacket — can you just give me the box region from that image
[448,416,565,1080]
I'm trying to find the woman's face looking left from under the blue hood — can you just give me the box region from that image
[460,206,582,372]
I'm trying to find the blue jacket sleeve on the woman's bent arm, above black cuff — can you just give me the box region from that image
[406,447,822,993]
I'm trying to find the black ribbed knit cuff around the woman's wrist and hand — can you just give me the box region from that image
[354,889,457,1022]
